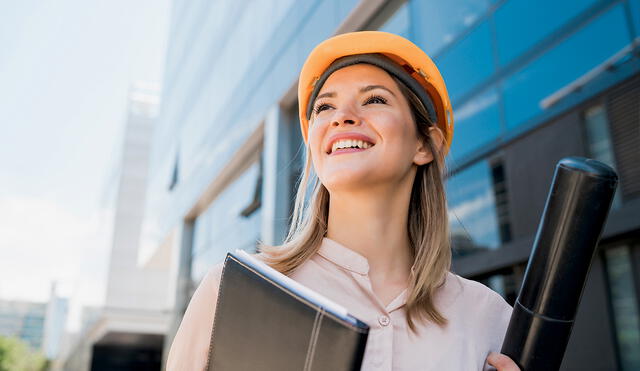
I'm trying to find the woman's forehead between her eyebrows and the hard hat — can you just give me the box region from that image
[318,63,397,94]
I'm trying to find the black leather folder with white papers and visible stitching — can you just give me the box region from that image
[207,251,369,371]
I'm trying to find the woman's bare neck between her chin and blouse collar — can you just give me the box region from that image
[327,177,413,282]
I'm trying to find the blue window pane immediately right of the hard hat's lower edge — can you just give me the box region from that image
[451,88,500,159]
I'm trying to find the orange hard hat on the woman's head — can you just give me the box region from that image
[298,31,453,152]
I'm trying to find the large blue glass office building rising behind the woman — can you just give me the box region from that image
[145,0,640,370]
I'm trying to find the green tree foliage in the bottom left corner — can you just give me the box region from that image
[0,336,47,371]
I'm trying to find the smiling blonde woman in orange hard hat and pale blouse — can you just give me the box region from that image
[168,31,518,371]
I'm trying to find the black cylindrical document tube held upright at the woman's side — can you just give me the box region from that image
[502,157,618,371]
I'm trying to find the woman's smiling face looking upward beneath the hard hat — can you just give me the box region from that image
[308,64,433,192]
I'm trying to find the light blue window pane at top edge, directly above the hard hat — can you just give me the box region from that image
[409,0,491,56]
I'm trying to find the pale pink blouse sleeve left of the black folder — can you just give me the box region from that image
[166,263,223,371]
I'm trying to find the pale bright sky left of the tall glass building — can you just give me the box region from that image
[0,0,170,332]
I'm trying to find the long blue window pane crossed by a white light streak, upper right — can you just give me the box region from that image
[504,5,629,131]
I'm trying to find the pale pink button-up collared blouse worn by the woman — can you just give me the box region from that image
[167,237,512,371]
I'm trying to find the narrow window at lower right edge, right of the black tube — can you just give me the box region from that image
[605,246,640,371]
